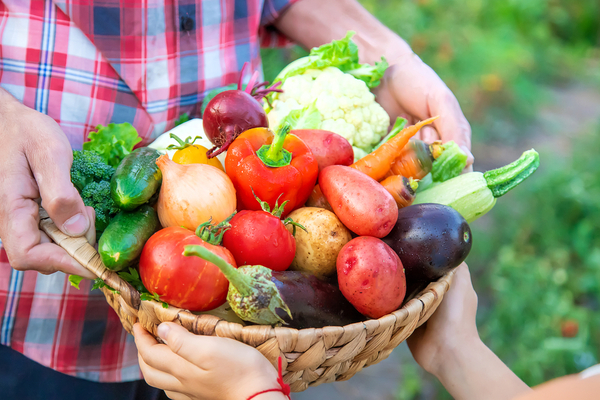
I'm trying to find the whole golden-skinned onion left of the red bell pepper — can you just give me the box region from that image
[156,155,236,230]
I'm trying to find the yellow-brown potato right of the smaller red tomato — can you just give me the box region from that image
[287,207,352,278]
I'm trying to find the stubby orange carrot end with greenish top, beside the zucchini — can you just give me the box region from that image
[388,139,443,179]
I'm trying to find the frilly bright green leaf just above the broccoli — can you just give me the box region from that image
[83,122,142,167]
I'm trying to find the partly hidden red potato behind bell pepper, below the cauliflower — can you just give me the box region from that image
[290,129,354,171]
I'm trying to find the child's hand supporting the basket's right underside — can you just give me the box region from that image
[407,263,480,375]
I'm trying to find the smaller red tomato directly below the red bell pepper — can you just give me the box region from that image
[223,210,296,271]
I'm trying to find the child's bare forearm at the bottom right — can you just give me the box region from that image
[431,340,531,400]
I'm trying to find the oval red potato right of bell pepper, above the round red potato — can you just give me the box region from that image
[319,165,398,238]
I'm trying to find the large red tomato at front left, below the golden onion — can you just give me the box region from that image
[140,227,237,311]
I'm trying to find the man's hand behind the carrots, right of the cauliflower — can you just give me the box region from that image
[374,52,473,169]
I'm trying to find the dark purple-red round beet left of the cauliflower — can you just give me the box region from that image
[202,90,269,158]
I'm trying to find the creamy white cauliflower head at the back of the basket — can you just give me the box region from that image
[267,67,390,159]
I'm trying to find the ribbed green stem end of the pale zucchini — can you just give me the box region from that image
[483,149,540,197]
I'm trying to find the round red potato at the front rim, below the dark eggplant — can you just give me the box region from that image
[336,236,406,318]
